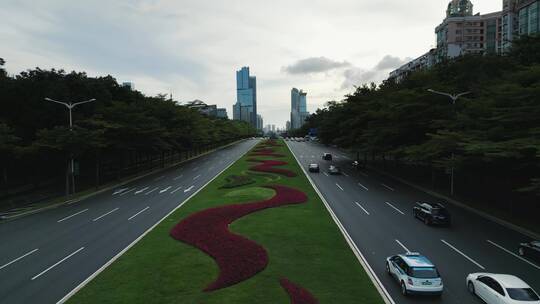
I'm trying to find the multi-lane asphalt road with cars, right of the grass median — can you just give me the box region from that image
[287,141,540,304]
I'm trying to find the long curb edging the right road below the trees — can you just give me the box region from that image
[368,166,540,240]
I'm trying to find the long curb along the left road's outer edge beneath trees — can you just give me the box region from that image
[0,139,245,224]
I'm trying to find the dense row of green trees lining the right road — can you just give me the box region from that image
[299,37,540,200]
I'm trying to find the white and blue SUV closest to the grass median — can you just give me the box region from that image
[386,252,443,296]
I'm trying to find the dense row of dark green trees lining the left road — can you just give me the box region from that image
[0,59,255,203]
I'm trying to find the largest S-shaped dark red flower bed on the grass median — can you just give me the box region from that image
[170,185,307,291]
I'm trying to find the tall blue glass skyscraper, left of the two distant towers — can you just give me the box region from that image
[233,67,257,128]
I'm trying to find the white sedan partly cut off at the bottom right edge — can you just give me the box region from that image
[467,273,540,304]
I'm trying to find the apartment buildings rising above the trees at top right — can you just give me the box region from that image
[390,0,540,82]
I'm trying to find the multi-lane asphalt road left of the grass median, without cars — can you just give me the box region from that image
[0,140,258,304]
